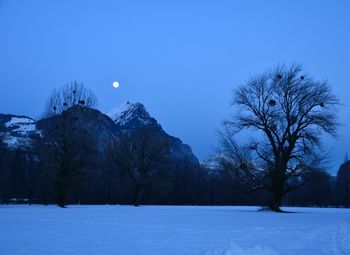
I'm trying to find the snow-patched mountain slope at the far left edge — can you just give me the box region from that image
[0,114,40,149]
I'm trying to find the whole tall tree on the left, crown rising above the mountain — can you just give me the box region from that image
[38,82,97,207]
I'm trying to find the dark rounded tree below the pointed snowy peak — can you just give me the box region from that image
[109,127,170,206]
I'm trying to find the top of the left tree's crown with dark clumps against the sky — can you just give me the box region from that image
[43,81,97,118]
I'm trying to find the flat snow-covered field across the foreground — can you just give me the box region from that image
[0,205,350,255]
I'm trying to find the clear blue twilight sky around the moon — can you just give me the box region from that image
[0,0,350,172]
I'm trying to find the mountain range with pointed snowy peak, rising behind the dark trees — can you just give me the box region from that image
[0,102,199,164]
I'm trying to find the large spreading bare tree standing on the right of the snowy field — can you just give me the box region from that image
[220,65,339,211]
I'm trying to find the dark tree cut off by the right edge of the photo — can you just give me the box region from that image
[336,160,350,207]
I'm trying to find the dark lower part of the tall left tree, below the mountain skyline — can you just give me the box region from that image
[43,105,96,207]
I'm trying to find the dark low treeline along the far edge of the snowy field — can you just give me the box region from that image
[0,143,350,207]
